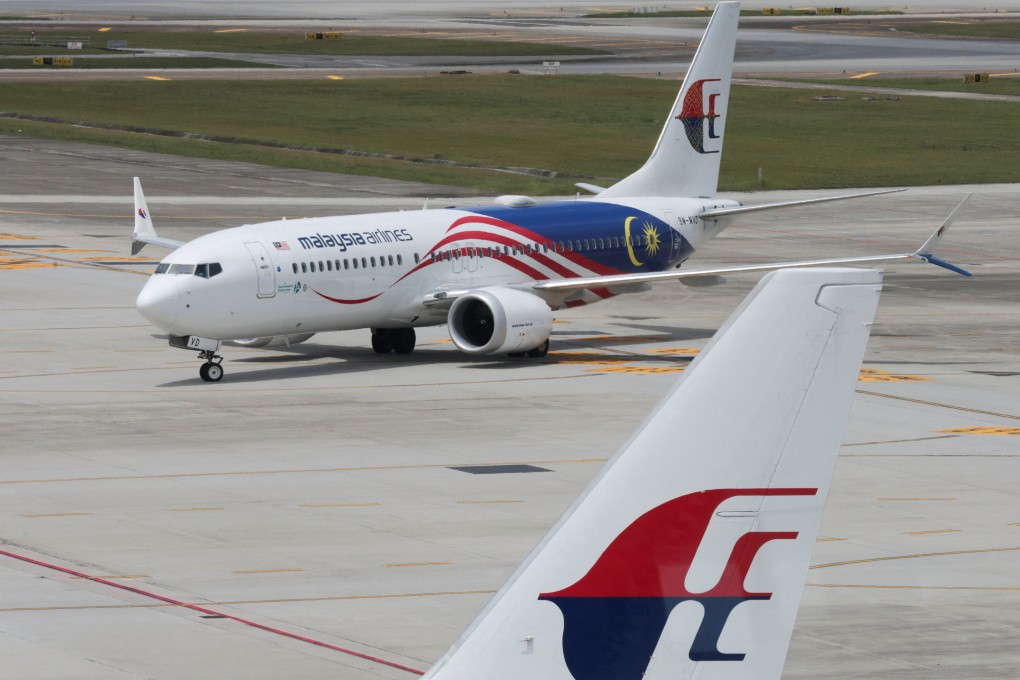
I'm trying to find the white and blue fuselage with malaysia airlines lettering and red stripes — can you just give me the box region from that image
[138,199,736,339]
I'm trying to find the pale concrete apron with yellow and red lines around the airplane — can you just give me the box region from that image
[0,131,1020,680]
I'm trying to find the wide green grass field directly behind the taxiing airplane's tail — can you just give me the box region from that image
[0,75,1020,195]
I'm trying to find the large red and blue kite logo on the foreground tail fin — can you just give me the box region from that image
[539,488,818,680]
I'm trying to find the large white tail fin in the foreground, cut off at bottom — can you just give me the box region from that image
[425,268,881,680]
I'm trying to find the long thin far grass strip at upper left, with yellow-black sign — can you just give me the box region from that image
[0,29,604,57]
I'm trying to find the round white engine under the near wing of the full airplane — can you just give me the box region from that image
[448,289,553,354]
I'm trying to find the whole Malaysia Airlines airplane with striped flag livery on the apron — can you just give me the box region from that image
[132,2,969,382]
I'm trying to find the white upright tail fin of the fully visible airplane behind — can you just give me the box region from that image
[599,2,741,198]
